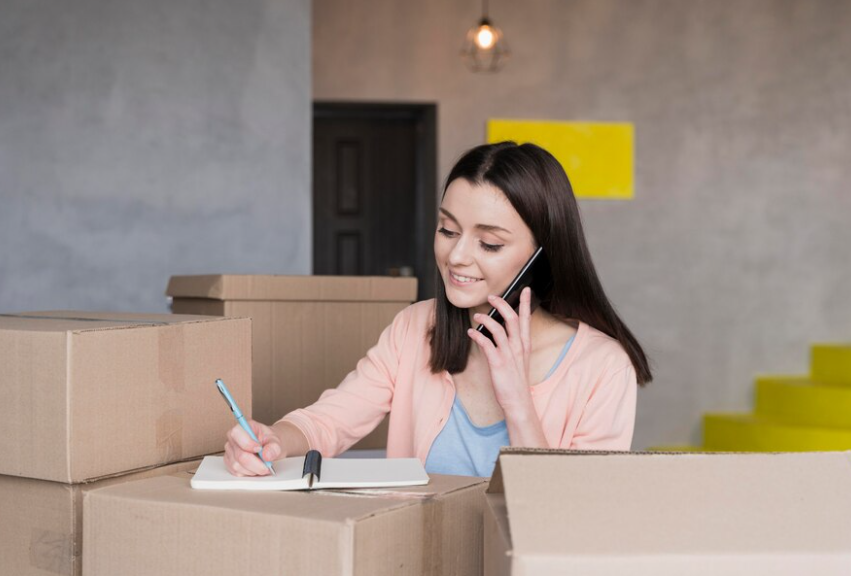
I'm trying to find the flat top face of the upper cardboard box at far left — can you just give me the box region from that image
[0,310,223,332]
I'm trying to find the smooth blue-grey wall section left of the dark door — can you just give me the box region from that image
[0,0,312,312]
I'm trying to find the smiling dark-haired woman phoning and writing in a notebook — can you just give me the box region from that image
[225,142,651,476]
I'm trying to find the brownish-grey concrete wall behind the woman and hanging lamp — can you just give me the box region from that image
[313,0,851,448]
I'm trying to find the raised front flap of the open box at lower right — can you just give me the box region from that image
[499,452,851,558]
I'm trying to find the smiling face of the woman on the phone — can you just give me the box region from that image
[434,178,536,312]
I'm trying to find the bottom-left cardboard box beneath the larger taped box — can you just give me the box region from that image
[0,460,199,576]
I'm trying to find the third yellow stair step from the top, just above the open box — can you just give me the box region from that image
[703,414,851,452]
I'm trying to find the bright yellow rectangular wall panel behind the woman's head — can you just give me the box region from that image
[488,119,635,200]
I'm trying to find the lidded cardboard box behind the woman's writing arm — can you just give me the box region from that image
[166,275,417,449]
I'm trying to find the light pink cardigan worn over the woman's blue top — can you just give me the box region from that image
[283,300,637,463]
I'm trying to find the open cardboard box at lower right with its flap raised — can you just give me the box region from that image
[484,449,851,576]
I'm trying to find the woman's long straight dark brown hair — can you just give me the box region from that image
[429,142,653,385]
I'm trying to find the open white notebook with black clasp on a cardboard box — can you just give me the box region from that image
[191,450,428,490]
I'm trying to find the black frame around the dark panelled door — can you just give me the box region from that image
[311,100,439,300]
